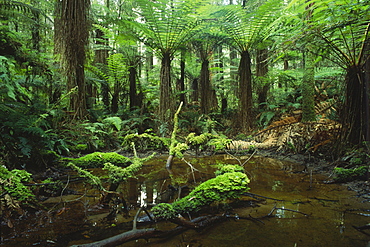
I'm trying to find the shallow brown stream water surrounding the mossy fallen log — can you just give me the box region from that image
[0,155,370,247]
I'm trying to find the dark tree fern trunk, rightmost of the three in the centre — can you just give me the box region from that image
[238,51,253,132]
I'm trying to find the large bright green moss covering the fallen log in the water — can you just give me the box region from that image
[153,172,250,219]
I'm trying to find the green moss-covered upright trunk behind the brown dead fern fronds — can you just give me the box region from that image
[301,49,316,122]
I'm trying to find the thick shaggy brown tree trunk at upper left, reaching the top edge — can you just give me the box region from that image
[58,0,90,119]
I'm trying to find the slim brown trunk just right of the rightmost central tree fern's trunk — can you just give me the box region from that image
[256,49,270,109]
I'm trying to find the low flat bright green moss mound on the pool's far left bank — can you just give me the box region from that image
[68,152,131,168]
